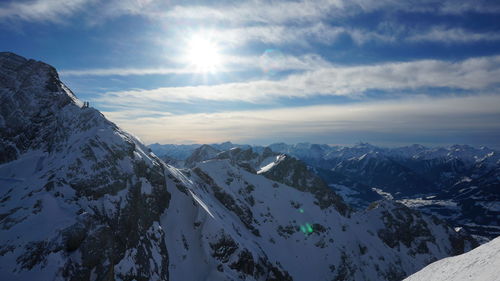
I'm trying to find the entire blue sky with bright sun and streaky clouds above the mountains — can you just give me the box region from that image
[0,0,500,148]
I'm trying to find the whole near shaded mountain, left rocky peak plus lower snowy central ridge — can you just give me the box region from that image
[0,53,476,280]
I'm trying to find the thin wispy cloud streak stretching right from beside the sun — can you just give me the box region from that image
[209,23,500,46]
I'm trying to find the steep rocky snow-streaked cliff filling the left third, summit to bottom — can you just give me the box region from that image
[0,53,170,280]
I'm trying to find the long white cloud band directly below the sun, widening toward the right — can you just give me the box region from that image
[97,56,500,104]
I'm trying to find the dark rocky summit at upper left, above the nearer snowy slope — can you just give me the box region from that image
[0,53,110,162]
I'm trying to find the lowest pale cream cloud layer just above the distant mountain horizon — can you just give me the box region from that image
[104,96,500,143]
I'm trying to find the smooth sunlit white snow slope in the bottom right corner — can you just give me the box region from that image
[405,234,500,281]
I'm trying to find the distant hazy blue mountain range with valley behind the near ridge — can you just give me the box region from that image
[149,142,500,239]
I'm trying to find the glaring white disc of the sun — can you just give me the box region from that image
[186,34,222,72]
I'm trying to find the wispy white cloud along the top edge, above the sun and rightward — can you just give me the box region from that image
[161,0,500,24]
